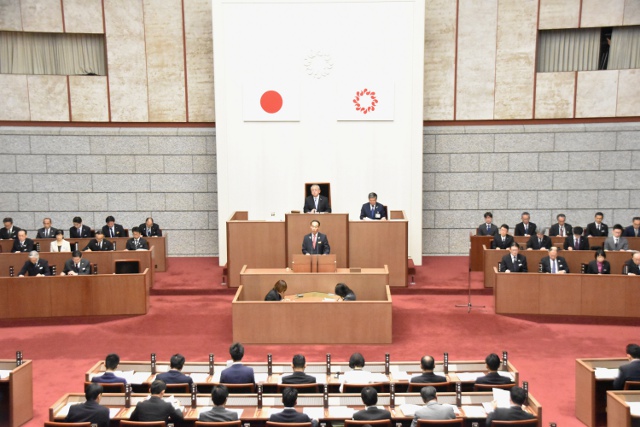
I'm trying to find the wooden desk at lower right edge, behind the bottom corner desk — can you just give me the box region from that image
[576,358,629,427]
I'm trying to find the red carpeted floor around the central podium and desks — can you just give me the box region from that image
[0,257,640,427]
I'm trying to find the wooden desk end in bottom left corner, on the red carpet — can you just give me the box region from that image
[0,359,33,427]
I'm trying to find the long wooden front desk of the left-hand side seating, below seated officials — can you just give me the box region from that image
[0,268,151,319]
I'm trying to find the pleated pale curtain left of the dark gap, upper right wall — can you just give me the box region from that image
[537,28,600,73]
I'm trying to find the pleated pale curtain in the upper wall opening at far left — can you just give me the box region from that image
[0,31,106,76]
